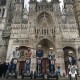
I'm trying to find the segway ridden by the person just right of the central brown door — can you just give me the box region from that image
[47,60,58,80]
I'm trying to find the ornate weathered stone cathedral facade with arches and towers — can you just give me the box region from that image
[0,0,80,73]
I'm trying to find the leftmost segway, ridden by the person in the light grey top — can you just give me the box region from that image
[6,58,18,79]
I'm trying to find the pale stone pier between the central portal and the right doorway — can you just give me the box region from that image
[56,49,65,76]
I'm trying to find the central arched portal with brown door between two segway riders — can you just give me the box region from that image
[38,39,55,73]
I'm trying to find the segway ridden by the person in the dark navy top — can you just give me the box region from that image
[34,57,44,79]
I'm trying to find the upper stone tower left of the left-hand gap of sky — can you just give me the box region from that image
[13,0,24,23]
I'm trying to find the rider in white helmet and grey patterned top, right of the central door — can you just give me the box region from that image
[48,48,55,72]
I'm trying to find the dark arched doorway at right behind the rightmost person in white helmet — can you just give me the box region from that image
[63,47,76,74]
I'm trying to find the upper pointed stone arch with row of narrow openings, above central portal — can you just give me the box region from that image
[34,11,55,39]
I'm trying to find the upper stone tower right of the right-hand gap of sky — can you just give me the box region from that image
[64,0,75,23]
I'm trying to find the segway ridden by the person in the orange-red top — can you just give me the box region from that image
[21,58,33,79]
